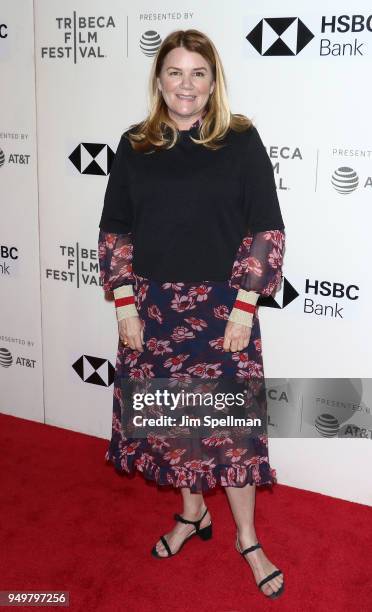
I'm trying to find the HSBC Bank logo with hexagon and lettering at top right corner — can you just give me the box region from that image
[246,14,372,57]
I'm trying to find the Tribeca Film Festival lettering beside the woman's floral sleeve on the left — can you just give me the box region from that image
[45,242,102,288]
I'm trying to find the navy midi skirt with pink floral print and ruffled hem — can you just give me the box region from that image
[105,275,276,493]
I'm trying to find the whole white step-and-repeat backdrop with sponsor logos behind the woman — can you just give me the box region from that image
[0,0,372,505]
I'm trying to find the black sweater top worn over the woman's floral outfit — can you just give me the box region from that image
[99,126,285,282]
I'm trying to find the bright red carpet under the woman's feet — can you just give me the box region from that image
[0,415,372,612]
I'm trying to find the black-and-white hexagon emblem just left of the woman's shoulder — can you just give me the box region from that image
[68,142,115,176]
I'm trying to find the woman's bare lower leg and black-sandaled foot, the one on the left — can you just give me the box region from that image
[156,487,211,557]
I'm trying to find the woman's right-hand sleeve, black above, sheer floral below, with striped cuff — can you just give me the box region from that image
[229,127,285,326]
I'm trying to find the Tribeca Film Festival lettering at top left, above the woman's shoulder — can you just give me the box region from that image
[41,11,116,64]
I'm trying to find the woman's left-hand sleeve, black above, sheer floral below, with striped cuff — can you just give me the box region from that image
[98,135,138,321]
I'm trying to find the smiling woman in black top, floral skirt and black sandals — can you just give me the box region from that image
[99,30,284,598]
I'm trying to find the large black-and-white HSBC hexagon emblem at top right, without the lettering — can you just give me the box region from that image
[246,17,314,56]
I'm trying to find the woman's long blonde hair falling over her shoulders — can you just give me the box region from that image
[128,30,252,152]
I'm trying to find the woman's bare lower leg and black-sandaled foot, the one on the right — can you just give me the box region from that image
[225,484,283,595]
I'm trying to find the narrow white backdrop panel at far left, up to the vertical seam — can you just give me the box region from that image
[0,2,44,422]
